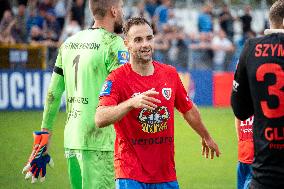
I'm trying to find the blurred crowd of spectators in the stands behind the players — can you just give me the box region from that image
[0,0,267,71]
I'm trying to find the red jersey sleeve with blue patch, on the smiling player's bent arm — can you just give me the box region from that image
[99,73,119,106]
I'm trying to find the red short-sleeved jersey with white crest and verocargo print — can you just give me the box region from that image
[99,62,192,183]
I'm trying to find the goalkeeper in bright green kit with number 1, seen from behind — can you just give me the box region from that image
[21,0,128,189]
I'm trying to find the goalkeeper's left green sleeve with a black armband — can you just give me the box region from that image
[41,46,65,130]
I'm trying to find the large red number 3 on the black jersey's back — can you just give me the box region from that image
[256,63,284,118]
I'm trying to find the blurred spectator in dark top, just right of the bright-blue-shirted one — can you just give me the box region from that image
[219,4,234,41]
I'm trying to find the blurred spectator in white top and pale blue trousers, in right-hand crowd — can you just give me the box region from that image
[212,30,234,71]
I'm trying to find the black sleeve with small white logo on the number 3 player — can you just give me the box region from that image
[231,40,254,120]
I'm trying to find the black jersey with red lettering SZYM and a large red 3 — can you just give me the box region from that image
[231,30,284,189]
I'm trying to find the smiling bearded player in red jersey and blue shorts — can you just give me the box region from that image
[95,18,220,189]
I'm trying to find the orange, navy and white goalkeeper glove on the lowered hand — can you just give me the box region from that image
[23,132,54,183]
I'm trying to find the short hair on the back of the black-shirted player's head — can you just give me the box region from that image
[269,0,284,27]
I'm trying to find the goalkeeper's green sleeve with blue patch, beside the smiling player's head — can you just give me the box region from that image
[106,36,129,73]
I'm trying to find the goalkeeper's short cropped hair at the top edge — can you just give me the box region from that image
[90,0,119,19]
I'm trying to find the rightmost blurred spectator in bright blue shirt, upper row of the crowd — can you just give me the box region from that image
[198,4,213,32]
